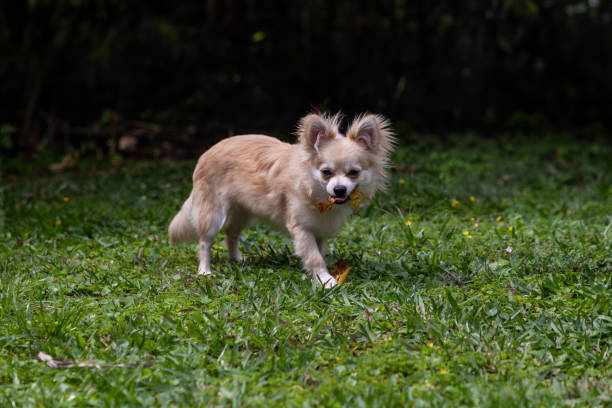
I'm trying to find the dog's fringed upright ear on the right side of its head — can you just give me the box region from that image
[347,114,395,156]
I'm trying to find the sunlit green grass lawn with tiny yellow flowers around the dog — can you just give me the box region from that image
[0,136,612,407]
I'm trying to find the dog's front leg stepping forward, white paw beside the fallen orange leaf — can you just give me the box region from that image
[288,225,338,288]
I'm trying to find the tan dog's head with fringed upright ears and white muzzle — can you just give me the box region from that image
[298,114,395,204]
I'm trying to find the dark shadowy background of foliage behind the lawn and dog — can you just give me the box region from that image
[0,0,612,157]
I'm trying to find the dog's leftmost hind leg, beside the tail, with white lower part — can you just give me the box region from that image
[198,202,227,275]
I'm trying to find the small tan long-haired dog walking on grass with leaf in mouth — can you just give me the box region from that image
[168,114,395,287]
